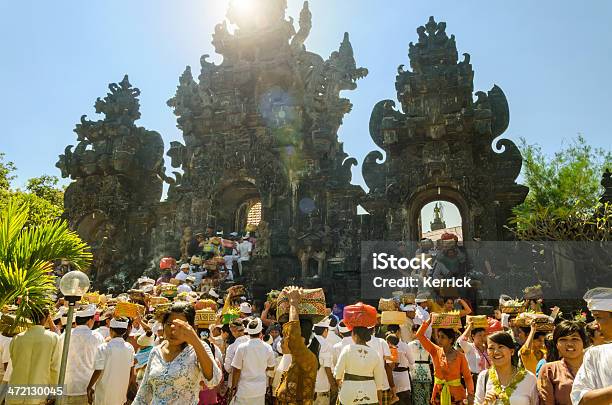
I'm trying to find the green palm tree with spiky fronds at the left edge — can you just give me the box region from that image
[0,199,92,325]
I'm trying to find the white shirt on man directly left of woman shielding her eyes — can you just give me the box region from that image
[94,337,134,405]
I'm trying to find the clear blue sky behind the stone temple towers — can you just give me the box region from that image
[0,0,612,227]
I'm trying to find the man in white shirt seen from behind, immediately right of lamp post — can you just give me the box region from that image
[59,304,104,405]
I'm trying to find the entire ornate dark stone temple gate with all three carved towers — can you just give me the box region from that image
[57,0,527,302]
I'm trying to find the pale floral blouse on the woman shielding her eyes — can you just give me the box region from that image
[132,345,221,405]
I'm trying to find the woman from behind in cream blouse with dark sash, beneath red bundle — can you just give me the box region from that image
[334,327,385,405]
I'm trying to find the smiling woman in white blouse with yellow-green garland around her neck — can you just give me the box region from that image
[475,332,538,405]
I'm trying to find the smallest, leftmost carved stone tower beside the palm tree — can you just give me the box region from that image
[56,75,164,287]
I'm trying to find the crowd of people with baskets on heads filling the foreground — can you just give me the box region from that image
[0,251,612,405]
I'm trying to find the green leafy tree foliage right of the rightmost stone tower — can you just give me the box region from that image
[511,136,612,241]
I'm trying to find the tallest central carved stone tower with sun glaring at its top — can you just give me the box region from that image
[153,0,367,296]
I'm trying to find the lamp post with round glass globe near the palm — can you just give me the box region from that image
[57,270,90,404]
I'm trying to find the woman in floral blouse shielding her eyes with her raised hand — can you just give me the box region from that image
[132,302,221,405]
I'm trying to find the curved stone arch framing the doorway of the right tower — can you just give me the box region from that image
[408,187,474,241]
